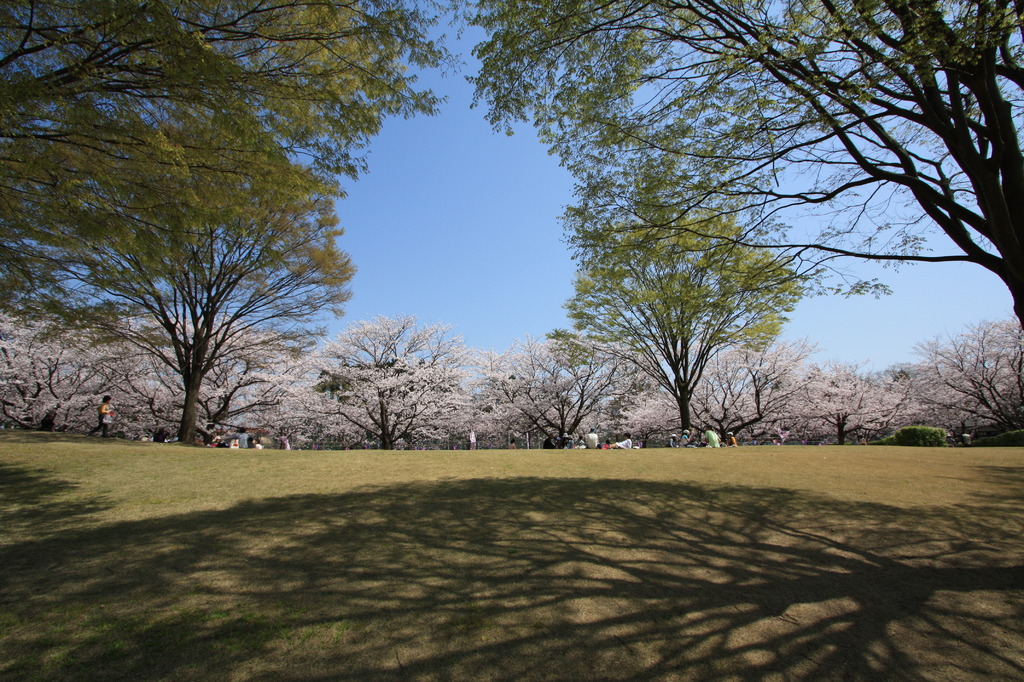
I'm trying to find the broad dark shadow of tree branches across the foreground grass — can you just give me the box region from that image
[0,478,1024,680]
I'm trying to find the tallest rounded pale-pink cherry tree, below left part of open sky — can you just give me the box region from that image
[319,316,469,450]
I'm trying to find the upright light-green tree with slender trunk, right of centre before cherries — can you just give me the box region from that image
[566,220,802,429]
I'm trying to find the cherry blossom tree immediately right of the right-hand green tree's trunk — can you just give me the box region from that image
[691,341,817,435]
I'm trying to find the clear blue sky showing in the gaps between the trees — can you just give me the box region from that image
[328,33,1012,370]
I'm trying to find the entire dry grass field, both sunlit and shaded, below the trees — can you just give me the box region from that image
[0,431,1024,681]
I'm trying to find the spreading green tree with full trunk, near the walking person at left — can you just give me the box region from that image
[55,184,354,442]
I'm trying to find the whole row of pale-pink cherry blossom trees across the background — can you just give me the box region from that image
[0,317,1024,450]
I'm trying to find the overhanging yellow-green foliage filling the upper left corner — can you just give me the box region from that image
[0,0,444,302]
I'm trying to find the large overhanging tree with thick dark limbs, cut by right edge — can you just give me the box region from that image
[473,0,1024,327]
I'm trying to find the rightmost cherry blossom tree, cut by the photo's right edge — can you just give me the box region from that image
[916,319,1024,431]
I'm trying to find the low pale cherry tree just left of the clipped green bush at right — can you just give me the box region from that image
[794,361,910,445]
